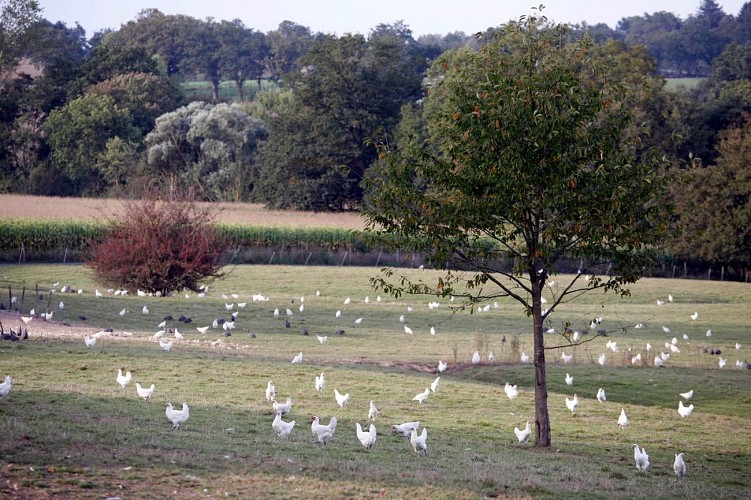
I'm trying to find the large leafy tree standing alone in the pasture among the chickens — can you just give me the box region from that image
[366,13,667,447]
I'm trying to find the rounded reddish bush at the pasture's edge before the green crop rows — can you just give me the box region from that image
[87,200,226,295]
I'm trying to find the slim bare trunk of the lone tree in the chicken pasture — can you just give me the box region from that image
[531,275,550,448]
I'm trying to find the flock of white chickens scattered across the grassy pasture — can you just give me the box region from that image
[0,282,745,476]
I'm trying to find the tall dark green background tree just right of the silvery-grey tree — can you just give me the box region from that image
[254,26,425,211]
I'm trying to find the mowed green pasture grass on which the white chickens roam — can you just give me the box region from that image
[0,265,751,498]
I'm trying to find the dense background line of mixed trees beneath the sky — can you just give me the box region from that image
[0,0,751,274]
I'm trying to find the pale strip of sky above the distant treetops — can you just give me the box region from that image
[39,0,746,37]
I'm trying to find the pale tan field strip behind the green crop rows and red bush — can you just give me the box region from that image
[0,194,365,229]
